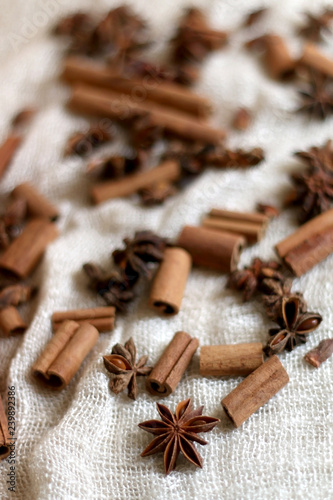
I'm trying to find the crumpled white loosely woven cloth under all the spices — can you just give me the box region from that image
[0,0,333,500]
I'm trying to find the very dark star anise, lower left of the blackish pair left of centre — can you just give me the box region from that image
[83,262,134,311]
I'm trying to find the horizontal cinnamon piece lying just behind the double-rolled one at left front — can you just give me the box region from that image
[52,306,116,332]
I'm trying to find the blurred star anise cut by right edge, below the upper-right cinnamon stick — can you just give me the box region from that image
[297,74,333,120]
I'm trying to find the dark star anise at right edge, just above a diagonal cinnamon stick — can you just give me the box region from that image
[285,168,333,223]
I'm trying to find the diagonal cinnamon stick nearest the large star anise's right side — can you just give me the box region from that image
[221,355,289,427]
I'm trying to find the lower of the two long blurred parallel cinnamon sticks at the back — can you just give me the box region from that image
[68,85,225,144]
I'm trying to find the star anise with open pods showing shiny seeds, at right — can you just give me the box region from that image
[265,296,322,356]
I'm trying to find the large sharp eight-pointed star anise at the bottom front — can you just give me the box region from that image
[139,399,219,474]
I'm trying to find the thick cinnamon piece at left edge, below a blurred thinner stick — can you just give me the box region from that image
[0,218,58,278]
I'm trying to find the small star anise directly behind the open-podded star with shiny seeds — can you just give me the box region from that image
[260,279,306,321]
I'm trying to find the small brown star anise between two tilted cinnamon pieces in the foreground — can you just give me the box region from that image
[103,338,152,399]
